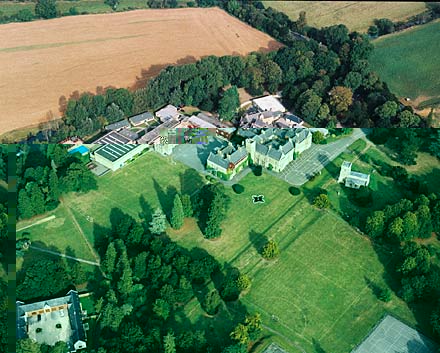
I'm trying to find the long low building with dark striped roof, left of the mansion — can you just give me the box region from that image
[90,144,148,171]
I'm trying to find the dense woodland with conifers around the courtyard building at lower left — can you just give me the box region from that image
[17,179,262,353]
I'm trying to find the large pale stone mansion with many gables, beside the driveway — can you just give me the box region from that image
[246,128,312,172]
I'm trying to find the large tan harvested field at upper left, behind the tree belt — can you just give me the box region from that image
[0,8,281,133]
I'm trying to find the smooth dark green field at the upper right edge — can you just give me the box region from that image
[370,20,440,100]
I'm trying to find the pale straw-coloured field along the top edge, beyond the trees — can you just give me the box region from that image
[263,0,426,32]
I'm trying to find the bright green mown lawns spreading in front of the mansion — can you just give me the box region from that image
[16,142,431,353]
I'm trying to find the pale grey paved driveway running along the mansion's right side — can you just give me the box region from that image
[269,129,366,186]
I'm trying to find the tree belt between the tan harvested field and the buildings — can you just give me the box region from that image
[16,0,430,142]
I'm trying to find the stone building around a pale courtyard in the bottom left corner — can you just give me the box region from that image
[16,290,87,352]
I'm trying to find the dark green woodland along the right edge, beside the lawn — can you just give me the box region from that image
[351,129,440,338]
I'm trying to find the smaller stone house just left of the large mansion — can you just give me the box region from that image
[206,142,249,180]
